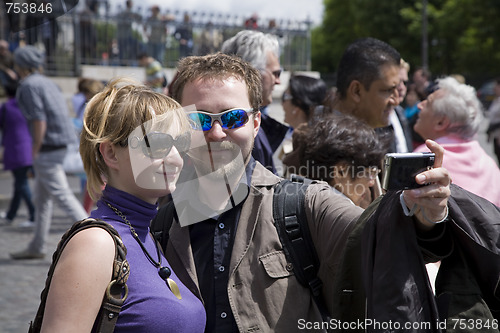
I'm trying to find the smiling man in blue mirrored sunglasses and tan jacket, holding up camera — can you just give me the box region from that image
[153,53,450,333]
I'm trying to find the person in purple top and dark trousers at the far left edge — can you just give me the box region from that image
[0,82,35,226]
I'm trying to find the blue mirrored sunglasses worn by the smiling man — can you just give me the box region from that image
[187,108,253,131]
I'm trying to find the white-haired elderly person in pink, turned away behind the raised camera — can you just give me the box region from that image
[414,77,500,206]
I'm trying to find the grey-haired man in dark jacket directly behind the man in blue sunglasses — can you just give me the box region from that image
[221,30,289,173]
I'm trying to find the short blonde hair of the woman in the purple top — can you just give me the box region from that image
[80,78,190,200]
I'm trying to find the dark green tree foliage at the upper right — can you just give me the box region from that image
[312,0,500,83]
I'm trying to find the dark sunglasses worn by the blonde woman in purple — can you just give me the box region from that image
[129,132,191,159]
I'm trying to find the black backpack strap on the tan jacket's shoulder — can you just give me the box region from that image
[273,175,330,321]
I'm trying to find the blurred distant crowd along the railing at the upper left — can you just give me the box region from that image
[0,0,290,69]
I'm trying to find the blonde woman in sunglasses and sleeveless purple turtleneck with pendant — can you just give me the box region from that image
[38,79,205,333]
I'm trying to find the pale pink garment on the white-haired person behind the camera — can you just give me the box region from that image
[415,136,500,206]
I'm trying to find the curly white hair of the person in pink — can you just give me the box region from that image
[432,76,483,140]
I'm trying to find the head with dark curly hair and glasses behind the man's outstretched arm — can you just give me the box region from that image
[289,114,388,208]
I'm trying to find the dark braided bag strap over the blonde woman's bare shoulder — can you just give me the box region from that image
[28,218,130,333]
